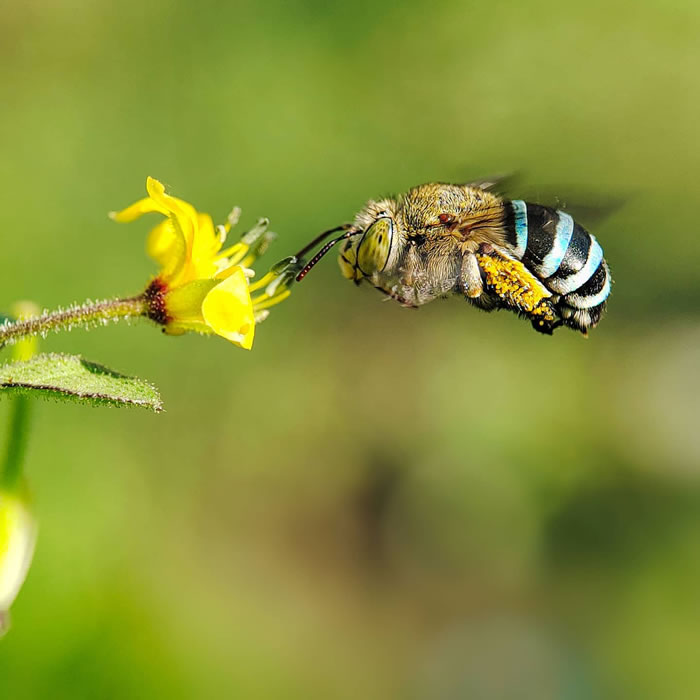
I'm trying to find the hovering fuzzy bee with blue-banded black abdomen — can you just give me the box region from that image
[296,183,612,335]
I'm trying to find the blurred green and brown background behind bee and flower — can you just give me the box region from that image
[0,0,700,700]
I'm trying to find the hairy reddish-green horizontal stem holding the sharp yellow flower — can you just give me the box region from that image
[0,295,148,347]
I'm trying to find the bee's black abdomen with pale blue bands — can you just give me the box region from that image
[505,200,611,330]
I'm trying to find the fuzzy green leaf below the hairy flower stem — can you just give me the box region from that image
[0,353,163,412]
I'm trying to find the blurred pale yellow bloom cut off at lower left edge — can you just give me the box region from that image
[0,489,36,635]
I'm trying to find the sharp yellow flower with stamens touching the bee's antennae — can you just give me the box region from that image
[110,177,292,349]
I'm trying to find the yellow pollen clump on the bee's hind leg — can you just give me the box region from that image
[476,254,555,321]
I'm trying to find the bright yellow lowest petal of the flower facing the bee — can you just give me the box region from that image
[202,267,255,350]
